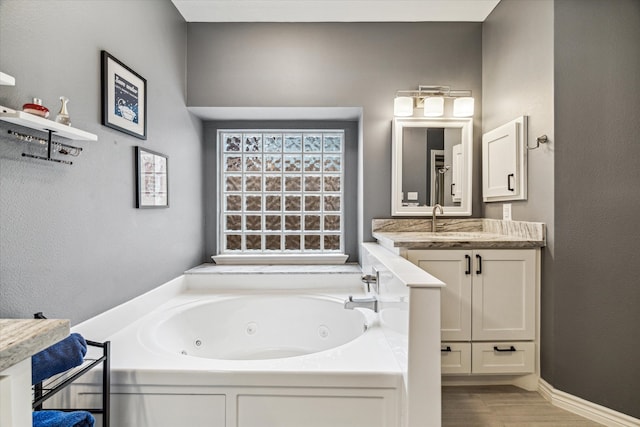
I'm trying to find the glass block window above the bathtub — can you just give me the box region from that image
[218,130,345,255]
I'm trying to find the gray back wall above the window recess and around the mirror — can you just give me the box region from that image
[187,23,482,246]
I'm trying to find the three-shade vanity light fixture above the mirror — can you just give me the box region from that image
[393,85,474,117]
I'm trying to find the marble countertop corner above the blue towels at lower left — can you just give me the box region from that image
[0,319,69,371]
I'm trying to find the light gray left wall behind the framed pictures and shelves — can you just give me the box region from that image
[0,0,203,323]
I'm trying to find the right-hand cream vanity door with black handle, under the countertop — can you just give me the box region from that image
[471,249,536,341]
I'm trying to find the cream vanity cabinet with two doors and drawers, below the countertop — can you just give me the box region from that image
[406,249,539,374]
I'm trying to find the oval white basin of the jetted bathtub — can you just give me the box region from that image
[140,292,368,360]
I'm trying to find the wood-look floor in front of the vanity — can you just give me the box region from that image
[442,386,601,427]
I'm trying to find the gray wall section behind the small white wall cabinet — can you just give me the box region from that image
[482,0,555,388]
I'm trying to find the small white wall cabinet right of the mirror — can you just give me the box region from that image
[482,116,527,202]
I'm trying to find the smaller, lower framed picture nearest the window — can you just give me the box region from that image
[136,147,169,208]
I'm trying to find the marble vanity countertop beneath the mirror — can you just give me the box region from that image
[372,218,546,251]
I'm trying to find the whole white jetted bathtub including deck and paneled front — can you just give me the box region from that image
[61,265,412,427]
